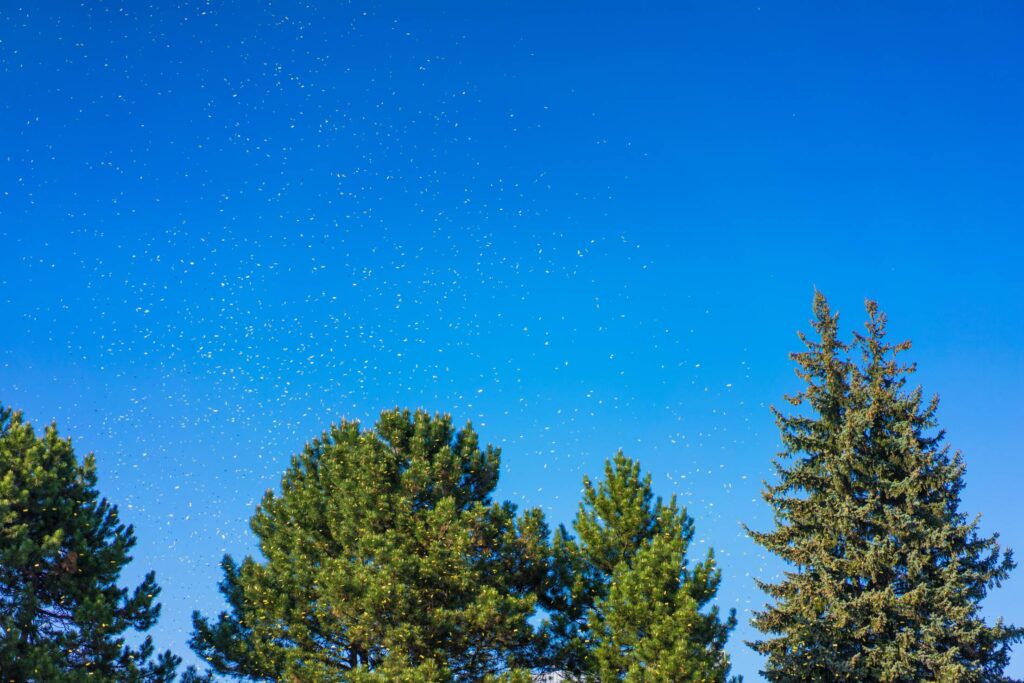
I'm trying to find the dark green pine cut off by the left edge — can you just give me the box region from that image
[0,407,179,683]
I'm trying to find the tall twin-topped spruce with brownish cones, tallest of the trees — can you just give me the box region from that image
[752,293,1022,683]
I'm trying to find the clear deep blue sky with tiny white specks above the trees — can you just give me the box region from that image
[0,0,1024,680]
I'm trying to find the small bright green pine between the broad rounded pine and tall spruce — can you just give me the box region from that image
[546,452,736,683]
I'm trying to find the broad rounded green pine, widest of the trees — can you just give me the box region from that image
[191,410,550,683]
